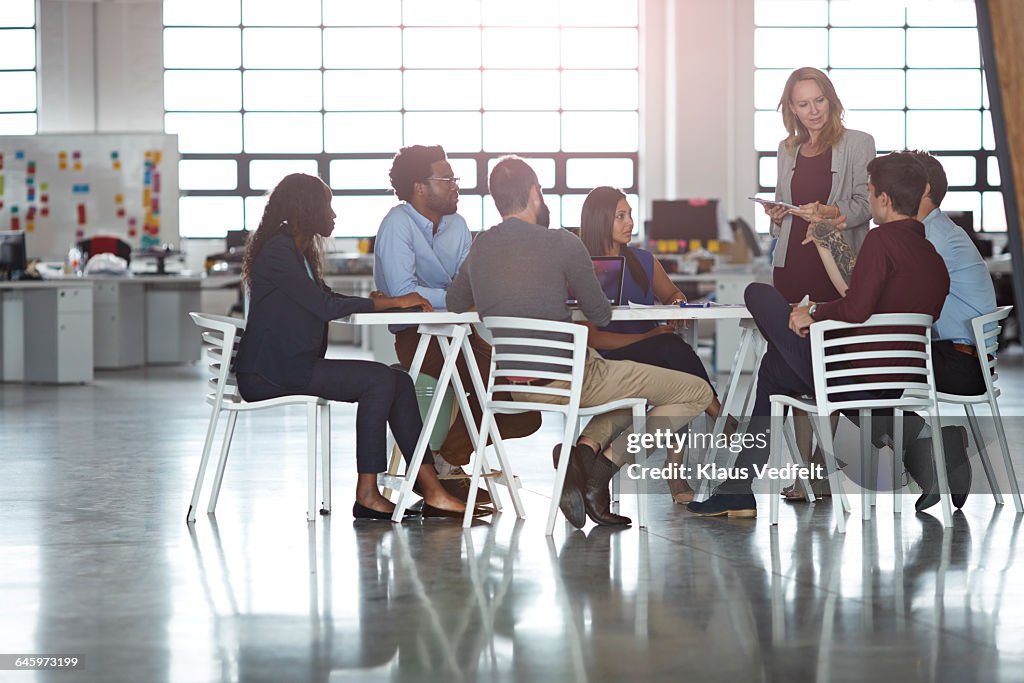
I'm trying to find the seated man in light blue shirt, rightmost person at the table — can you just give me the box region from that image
[913,152,995,395]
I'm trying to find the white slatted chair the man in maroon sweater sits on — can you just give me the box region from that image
[769,313,952,533]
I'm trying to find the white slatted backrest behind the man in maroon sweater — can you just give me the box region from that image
[810,313,935,415]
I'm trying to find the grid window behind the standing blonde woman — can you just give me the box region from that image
[754,0,1007,231]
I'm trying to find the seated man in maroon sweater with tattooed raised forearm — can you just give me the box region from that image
[688,153,970,517]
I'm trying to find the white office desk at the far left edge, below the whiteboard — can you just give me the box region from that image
[0,278,93,384]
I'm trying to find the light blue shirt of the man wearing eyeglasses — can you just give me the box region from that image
[374,202,472,332]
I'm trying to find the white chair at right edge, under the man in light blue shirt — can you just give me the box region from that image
[936,306,1024,512]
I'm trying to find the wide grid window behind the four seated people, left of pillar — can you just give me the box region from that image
[164,0,639,237]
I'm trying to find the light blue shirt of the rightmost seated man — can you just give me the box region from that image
[924,209,995,346]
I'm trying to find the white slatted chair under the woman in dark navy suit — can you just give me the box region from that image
[187,313,331,522]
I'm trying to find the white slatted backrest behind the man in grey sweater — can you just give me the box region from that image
[482,316,587,413]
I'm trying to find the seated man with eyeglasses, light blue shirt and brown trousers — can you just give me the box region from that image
[374,144,541,503]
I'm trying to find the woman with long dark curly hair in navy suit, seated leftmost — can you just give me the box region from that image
[234,173,477,519]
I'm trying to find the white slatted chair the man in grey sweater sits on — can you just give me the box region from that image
[463,316,647,536]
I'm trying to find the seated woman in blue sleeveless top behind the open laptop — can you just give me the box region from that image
[580,185,722,503]
